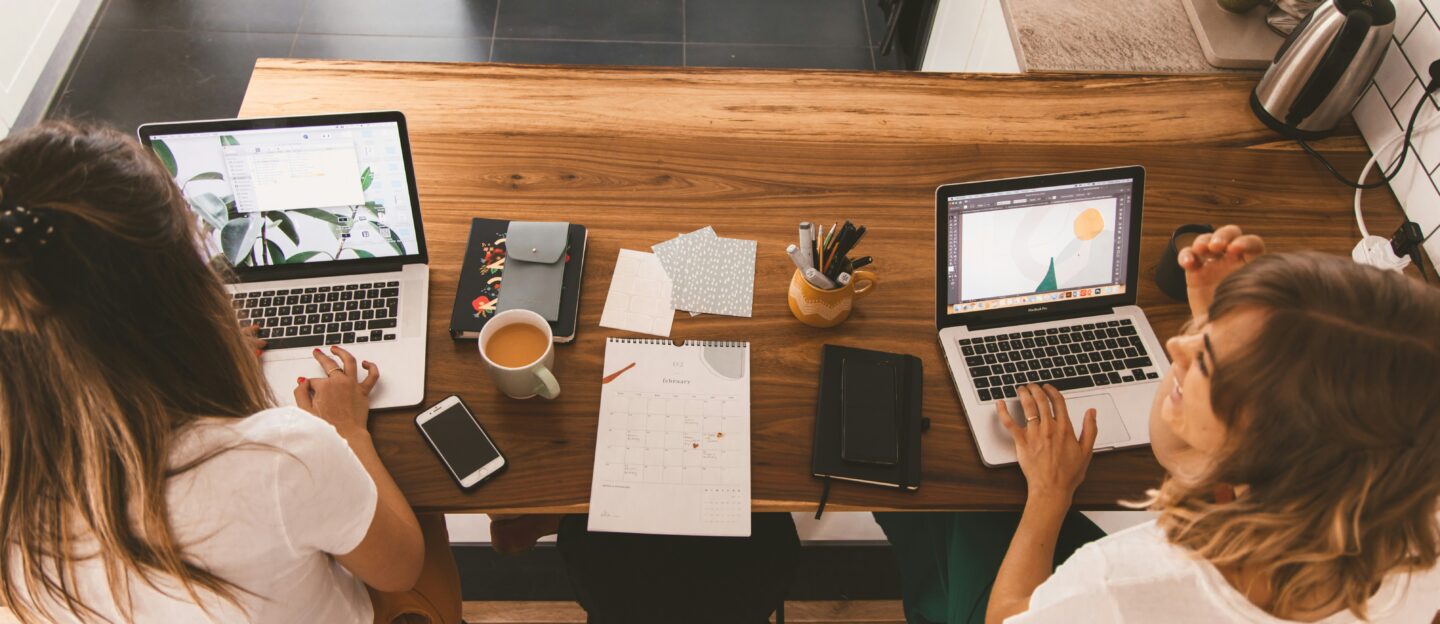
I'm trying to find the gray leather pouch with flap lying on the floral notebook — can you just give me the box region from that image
[495,220,570,321]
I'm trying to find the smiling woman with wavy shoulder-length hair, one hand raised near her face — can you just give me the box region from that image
[881,226,1440,624]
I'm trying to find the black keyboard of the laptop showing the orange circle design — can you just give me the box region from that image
[960,318,1159,401]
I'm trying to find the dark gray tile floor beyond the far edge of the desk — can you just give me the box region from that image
[50,0,900,131]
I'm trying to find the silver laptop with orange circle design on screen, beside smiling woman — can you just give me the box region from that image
[935,167,1169,465]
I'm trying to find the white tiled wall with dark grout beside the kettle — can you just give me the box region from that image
[1344,0,1440,258]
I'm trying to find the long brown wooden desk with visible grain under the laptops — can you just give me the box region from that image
[240,59,1400,512]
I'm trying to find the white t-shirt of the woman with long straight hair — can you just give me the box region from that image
[12,408,377,624]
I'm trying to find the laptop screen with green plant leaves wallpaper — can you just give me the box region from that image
[150,121,419,268]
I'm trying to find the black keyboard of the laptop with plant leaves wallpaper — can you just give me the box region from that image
[232,281,400,350]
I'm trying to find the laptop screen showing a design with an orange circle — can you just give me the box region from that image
[945,179,1136,314]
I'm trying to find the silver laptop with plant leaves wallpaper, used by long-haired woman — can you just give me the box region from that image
[138,111,429,409]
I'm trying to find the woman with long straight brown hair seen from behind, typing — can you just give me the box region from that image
[0,122,459,623]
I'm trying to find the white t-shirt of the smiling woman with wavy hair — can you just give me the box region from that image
[1005,520,1440,624]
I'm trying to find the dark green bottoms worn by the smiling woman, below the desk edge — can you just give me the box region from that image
[876,512,1104,624]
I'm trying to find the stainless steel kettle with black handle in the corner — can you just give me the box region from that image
[1250,0,1395,140]
